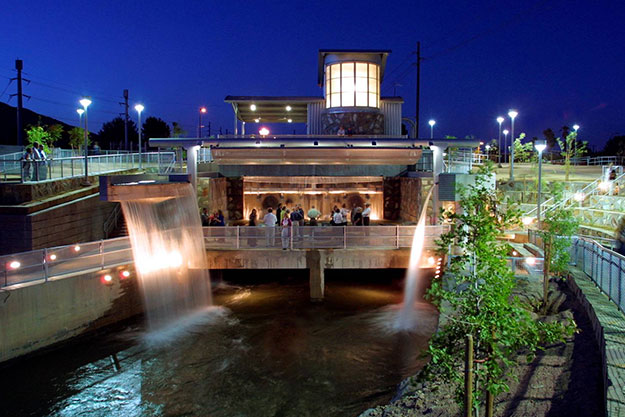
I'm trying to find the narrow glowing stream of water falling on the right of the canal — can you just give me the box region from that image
[394,185,436,330]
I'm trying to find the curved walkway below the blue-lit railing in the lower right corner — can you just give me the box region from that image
[570,268,625,417]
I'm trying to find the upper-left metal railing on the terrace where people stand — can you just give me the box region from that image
[0,152,174,182]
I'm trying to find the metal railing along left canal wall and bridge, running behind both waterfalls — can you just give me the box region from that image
[0,226,447,288]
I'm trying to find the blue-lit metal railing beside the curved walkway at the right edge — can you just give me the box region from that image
[570,237,625,313]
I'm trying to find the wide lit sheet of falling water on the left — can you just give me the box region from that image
[121,184,212,330]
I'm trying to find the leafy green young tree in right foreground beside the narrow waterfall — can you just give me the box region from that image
[426,164,572,408]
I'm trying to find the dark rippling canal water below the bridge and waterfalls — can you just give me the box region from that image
[0,271,436,417]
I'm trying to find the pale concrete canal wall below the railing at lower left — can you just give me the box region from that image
[0,270,143,362]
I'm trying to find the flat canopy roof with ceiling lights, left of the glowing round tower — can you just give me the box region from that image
[224,96,323,123]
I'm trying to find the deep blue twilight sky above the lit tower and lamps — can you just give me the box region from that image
[0,0,625,147]
